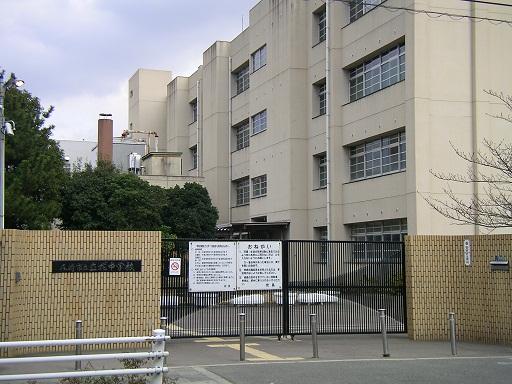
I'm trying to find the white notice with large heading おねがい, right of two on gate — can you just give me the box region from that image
[236,241,282,291]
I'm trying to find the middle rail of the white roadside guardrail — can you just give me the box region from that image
[0,352,169,365]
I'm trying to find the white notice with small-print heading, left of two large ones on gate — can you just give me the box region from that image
[188,241,236,292]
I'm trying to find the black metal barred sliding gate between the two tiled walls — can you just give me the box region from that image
[161,239,407,337]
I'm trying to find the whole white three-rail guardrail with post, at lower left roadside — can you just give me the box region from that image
[0,329,170,384]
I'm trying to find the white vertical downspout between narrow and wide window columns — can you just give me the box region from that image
[325,0,332,241]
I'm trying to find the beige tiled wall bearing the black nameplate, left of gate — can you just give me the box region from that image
[0,230,161,354]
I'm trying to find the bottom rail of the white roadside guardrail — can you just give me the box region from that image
[0,367,169,381]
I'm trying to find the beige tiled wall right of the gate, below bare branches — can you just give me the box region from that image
[405,235,512,344]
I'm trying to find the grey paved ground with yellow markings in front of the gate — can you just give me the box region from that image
[0,335,512,384]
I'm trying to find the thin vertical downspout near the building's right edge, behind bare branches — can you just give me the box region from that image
[470,3,480,235]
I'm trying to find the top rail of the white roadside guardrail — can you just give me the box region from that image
[0,336,170,348]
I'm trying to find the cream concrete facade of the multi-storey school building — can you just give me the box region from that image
[130,0,512,240]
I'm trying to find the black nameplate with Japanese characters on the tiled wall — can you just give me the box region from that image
[52,260,142,273]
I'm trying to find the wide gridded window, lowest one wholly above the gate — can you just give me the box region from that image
[350,131,406,180]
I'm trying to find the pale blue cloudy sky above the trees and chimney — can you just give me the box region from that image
[0,0,258,141]
